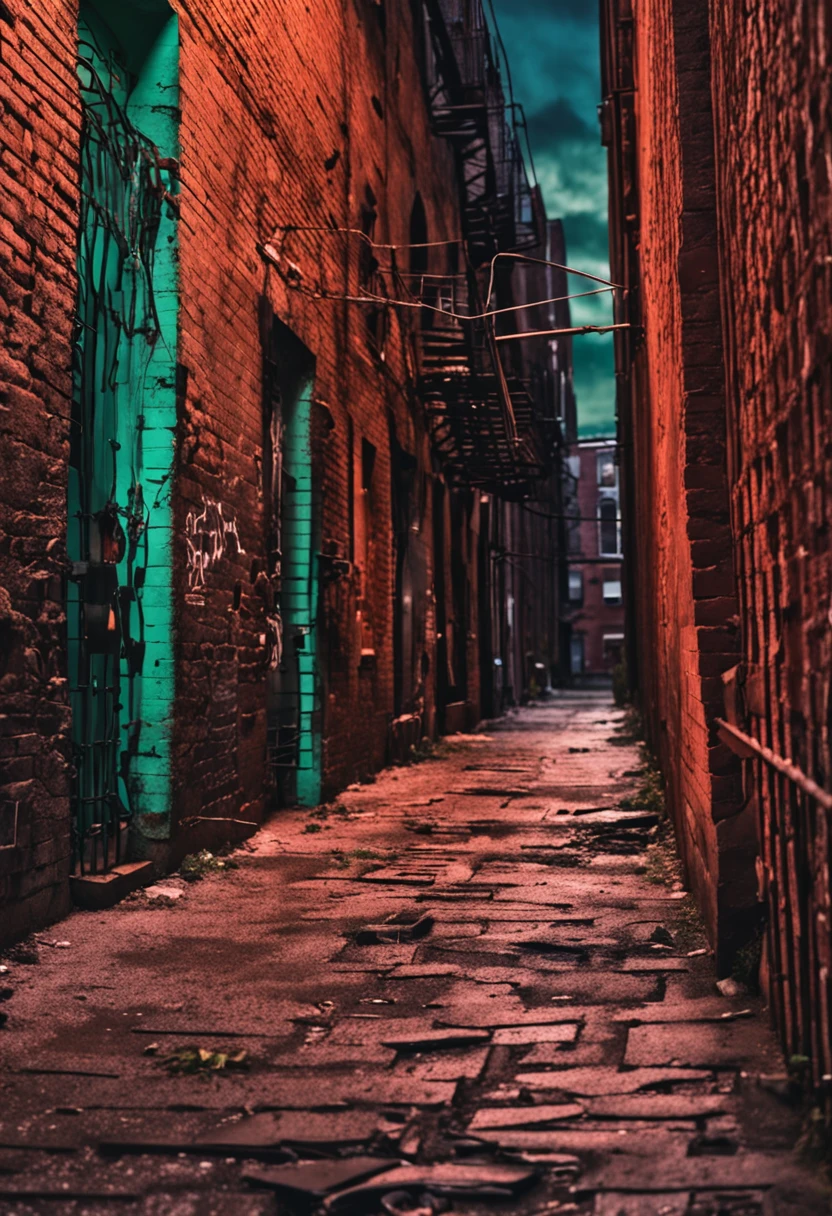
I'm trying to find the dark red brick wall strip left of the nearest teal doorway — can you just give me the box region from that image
[0,0,79,938]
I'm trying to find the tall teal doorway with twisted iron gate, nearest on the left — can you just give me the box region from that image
[67,4,179,872]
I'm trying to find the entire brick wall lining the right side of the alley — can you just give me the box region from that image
[605,0,832,1074]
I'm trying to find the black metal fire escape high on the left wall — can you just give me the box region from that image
[421,0,551,499]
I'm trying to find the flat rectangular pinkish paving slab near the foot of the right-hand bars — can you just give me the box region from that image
[624,1021,755,1068]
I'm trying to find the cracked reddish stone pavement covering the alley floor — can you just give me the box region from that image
[0,693,828,1216]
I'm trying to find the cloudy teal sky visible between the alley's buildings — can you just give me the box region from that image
[494,0,615,435]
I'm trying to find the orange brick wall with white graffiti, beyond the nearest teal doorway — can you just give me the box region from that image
[174,0,467,818]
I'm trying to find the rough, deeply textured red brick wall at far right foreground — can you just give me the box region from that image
[710,0,832,1079]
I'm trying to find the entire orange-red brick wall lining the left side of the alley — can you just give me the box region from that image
[0,0,559,935]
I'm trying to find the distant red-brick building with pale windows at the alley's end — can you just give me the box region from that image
[563,439,624,680]
